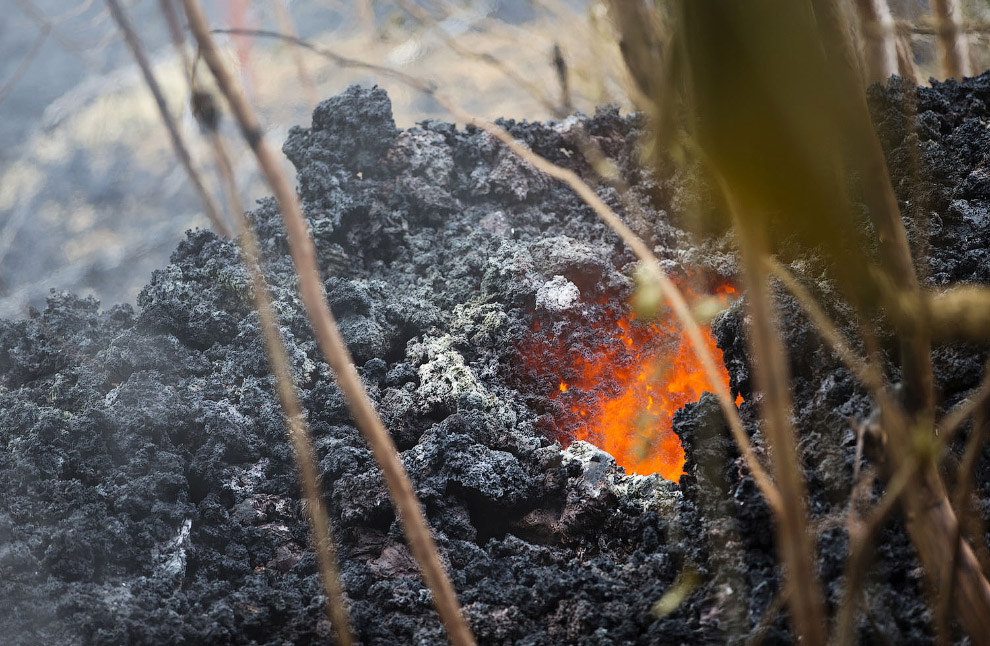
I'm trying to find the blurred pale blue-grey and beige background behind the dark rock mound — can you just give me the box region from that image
[0,0,990,317]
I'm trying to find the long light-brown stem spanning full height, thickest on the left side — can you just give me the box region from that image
[183,0,475,646]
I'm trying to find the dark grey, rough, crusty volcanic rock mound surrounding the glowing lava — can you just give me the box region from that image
[0,76,990,645]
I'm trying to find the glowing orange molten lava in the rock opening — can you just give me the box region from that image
[527,284,739,481]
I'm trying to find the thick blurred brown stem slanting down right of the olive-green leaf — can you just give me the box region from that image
[800,21,990,638]
